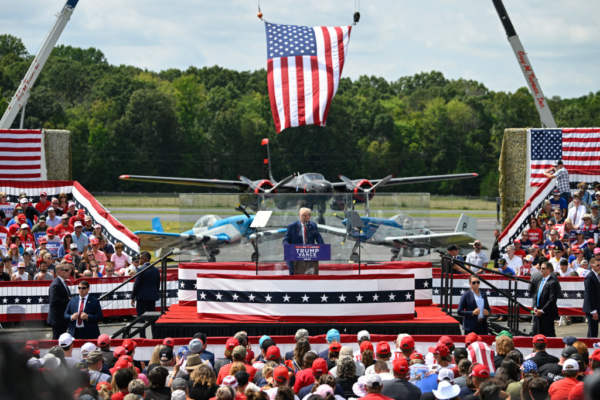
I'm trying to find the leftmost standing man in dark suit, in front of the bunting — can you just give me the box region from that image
[46,264,71,340]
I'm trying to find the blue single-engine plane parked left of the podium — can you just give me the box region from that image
[134,206,287,262]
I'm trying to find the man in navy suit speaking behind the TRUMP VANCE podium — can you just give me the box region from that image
[283,207,324,275]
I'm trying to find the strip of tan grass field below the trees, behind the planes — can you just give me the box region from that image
[93,193,496,212]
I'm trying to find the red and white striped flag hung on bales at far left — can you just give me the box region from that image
[0,129,43,180]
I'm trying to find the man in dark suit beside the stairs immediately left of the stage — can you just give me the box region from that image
[131,251,160,339]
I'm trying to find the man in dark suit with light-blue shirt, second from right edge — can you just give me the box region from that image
[531,262,561,337]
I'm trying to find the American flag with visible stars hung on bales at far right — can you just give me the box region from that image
[527,128,600,189]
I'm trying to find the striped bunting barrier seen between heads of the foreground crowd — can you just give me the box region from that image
[25,332,598,360]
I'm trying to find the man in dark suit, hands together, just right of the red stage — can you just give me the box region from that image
[458,275,492,335]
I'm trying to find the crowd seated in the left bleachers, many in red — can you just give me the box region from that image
[0,191,140,281]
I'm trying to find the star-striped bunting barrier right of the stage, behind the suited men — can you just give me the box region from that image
[433,272,585,316]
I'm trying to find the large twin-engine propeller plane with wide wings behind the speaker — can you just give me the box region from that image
[119,139,478,224]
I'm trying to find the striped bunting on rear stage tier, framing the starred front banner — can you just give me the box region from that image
[179,261,433,307]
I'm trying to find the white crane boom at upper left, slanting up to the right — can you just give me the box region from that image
[0,0,79,129]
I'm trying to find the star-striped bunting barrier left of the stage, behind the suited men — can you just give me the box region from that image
[0,272,178,323]
